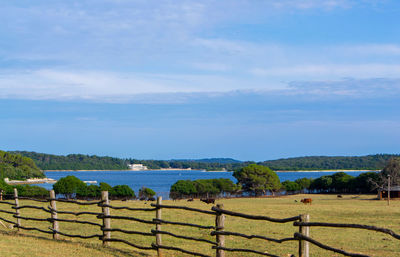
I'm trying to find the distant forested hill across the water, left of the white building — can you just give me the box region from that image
[13,151,127,170]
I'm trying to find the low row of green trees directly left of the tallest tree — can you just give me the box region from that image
[169,178,241,199]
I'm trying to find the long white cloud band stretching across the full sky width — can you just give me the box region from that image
[0,68,400,103]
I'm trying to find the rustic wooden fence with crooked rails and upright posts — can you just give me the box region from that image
[0,189,400,257]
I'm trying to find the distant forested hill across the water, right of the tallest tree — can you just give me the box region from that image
[259,154,400,170]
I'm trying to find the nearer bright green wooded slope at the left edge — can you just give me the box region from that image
[0,151,45,179]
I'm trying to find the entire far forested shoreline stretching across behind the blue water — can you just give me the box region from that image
[10,151,400,171]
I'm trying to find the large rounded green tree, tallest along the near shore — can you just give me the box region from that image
[233,164,281,196]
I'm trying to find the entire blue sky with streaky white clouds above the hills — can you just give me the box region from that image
[0,0,400,161]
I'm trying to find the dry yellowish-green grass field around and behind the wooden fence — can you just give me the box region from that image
[0,195,400,257]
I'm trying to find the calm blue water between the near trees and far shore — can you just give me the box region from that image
[36,170,374,199]
